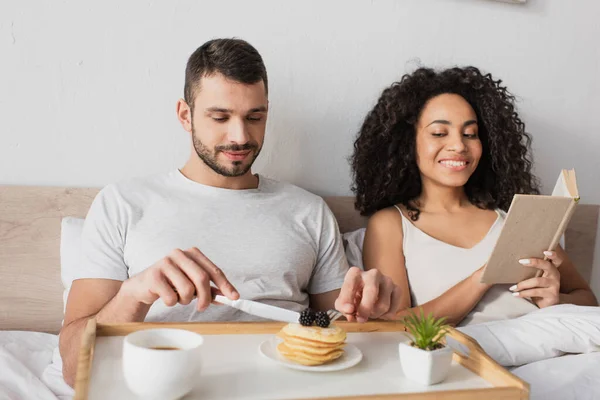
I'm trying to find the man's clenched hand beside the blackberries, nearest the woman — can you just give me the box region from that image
[335,267,400,322]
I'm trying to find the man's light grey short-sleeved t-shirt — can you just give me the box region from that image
[75,170,348,321]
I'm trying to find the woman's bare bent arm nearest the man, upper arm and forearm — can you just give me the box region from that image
[363,208,491,325]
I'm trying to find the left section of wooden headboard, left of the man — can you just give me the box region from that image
[0,186,98,333]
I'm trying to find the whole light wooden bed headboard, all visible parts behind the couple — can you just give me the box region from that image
[0,185,600,333]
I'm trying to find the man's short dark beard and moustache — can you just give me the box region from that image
[192,125,261,178]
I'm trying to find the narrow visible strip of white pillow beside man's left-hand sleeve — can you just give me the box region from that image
[60,217,85,313]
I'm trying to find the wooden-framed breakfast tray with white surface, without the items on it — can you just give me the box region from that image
[74,320,529,400]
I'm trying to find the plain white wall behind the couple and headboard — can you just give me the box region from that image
[0,0,600,290]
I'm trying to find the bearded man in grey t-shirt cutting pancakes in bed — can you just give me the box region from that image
[60,39,399,385]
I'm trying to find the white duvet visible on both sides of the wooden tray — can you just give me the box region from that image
[0,305,600,400]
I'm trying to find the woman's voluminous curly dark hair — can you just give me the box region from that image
[351,67,539,221]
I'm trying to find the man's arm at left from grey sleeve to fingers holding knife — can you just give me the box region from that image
[59,189,239,385]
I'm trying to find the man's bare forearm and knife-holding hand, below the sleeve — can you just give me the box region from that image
[59,247,239,385]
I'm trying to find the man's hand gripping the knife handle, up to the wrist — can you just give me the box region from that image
[121,247,240,311]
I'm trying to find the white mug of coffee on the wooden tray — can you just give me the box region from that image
[123,328,204,400]
